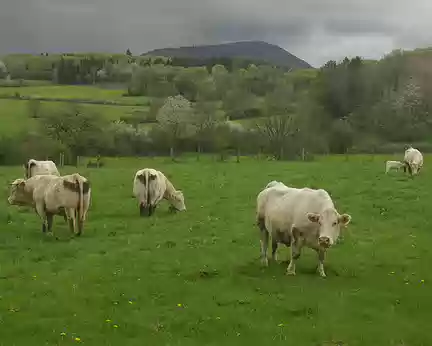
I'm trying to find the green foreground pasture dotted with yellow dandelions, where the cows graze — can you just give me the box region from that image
[0,156,432,346]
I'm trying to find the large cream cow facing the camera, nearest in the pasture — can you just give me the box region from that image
[256,183,351,277]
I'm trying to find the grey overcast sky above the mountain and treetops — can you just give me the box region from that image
[0,0,432,67]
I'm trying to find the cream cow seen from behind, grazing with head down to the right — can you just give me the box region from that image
[133,168,186,216]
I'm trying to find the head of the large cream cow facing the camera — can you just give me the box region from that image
[307,208,351,248]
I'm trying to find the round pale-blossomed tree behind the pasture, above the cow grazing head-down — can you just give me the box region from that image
[156,95,195,160]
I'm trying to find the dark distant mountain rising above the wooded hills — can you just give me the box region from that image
[142,41,312,69]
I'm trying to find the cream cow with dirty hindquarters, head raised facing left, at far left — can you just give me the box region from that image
[8,173,91,236]
